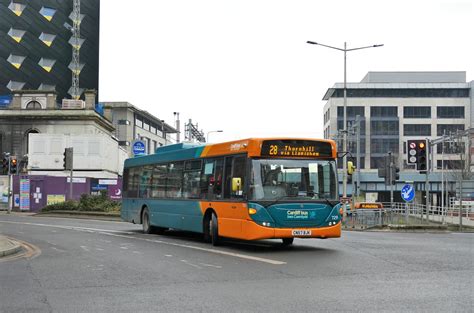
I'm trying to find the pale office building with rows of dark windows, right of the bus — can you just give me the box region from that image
[323,72,474,202]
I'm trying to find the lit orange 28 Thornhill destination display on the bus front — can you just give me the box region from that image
[261,140,332,158]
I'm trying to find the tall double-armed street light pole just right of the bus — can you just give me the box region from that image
[306,41,383,198]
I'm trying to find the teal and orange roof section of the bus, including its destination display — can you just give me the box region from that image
[125,138,337,167]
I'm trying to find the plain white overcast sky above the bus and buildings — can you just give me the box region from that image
[99,0,474,142]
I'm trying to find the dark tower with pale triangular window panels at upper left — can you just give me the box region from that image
[0,0,100,105]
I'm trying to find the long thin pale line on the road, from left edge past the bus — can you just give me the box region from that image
[0,221,286,265]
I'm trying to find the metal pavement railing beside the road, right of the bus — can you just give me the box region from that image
[343,202,474,229]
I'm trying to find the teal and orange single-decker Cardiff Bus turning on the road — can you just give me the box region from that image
[121,138,342,245]
